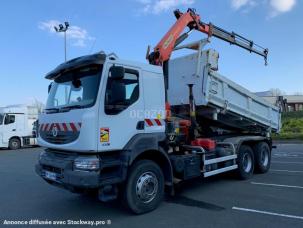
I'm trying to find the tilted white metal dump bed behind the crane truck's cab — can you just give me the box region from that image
[168,49,281,132]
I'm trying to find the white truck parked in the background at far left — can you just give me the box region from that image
[0,105,39,150]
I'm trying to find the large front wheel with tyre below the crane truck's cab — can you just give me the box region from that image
[123,160,164,214]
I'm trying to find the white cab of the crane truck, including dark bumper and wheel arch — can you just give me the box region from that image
[36,53,172,213]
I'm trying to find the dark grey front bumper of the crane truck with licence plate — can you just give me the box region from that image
[35,151,100,191]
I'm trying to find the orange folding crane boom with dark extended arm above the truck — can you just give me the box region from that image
[147,9,268,65]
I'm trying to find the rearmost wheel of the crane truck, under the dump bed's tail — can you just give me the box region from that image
[254,142,271,173]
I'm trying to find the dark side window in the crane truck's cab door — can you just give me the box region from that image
[105,69,139,115]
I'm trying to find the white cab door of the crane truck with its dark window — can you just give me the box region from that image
[98,63,144,151]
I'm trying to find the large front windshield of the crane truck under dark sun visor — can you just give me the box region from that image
[46,65,102,111]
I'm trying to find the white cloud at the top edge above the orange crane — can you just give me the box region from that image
[137,0,195,14]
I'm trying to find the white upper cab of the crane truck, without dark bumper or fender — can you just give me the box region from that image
[38,54,165,151]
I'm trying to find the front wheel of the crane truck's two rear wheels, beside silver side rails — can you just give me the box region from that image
[237,145,254,180]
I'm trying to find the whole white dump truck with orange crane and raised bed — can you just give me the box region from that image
[36,9,281,214]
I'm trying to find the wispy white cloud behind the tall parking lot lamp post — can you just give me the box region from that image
[38,20,95,47]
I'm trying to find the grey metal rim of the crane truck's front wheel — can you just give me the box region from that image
[136,172,158,203]
